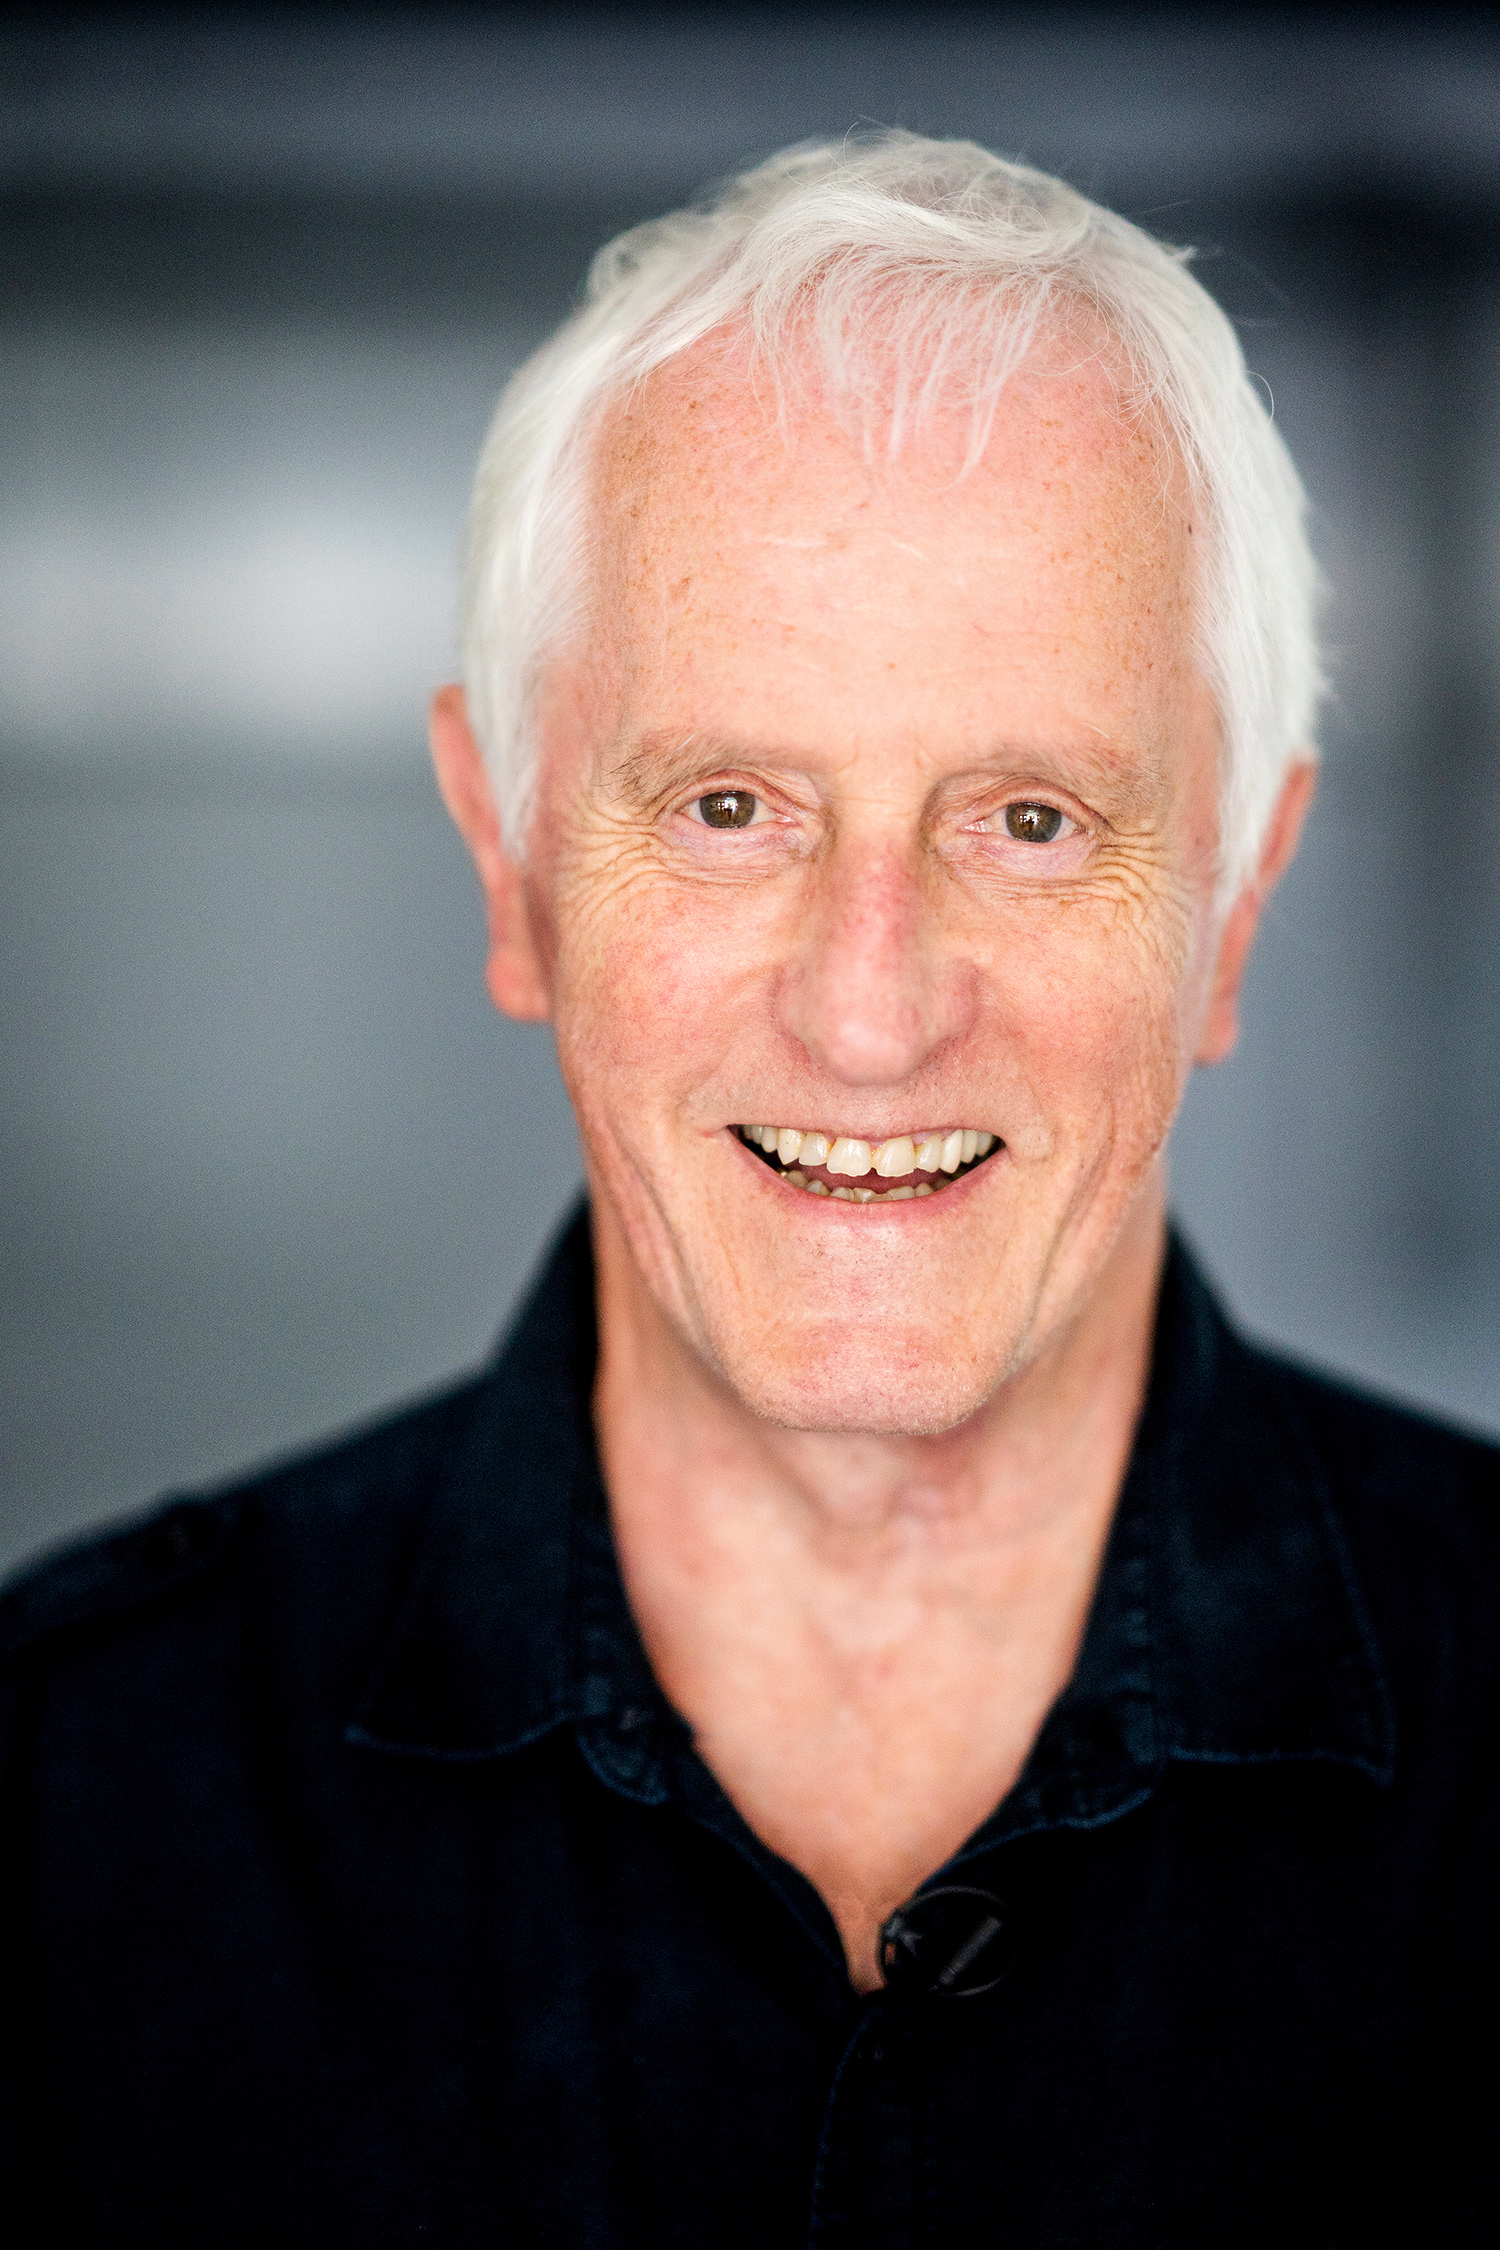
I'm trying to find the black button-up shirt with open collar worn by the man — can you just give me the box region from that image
[0,1222,1500,2250]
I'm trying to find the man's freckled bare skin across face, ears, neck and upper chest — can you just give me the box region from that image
[434,326,1311,1989]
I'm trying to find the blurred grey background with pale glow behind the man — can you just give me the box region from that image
[0,7,1500,1562]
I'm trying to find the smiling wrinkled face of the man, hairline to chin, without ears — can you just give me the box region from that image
[510,347,1217,1431]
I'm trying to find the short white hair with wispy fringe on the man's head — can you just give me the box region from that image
[461,131,1322,896]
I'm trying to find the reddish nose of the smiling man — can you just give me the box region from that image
[780,844,974,1087]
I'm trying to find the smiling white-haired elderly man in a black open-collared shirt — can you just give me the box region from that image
[4,135,1500,2250]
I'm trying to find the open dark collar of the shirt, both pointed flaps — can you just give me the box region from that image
[349,1211,1392,1809]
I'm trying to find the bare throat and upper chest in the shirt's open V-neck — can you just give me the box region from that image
[616,1422,1109,1991]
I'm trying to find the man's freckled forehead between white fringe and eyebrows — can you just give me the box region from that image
[580,340,1203,765]
